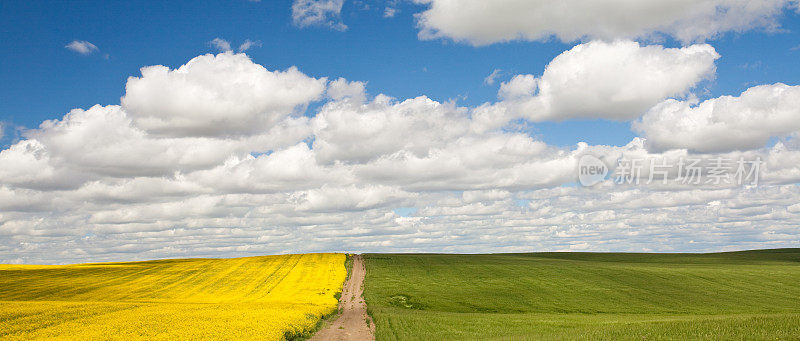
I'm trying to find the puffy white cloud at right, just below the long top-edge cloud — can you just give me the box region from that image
[475,40,719,130]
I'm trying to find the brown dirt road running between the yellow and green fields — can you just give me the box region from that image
[311,255,375,341]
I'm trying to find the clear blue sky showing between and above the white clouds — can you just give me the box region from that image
[0,0,800,146]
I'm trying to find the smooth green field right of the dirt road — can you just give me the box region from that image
[364,249,800,340]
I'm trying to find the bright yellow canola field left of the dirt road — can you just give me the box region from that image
[0,254,346,340]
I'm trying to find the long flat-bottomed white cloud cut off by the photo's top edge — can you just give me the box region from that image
[416,0,797,45]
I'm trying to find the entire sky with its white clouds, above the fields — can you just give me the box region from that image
[0,0,800,263]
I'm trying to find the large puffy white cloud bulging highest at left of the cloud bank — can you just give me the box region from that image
[122,52,326,136]
